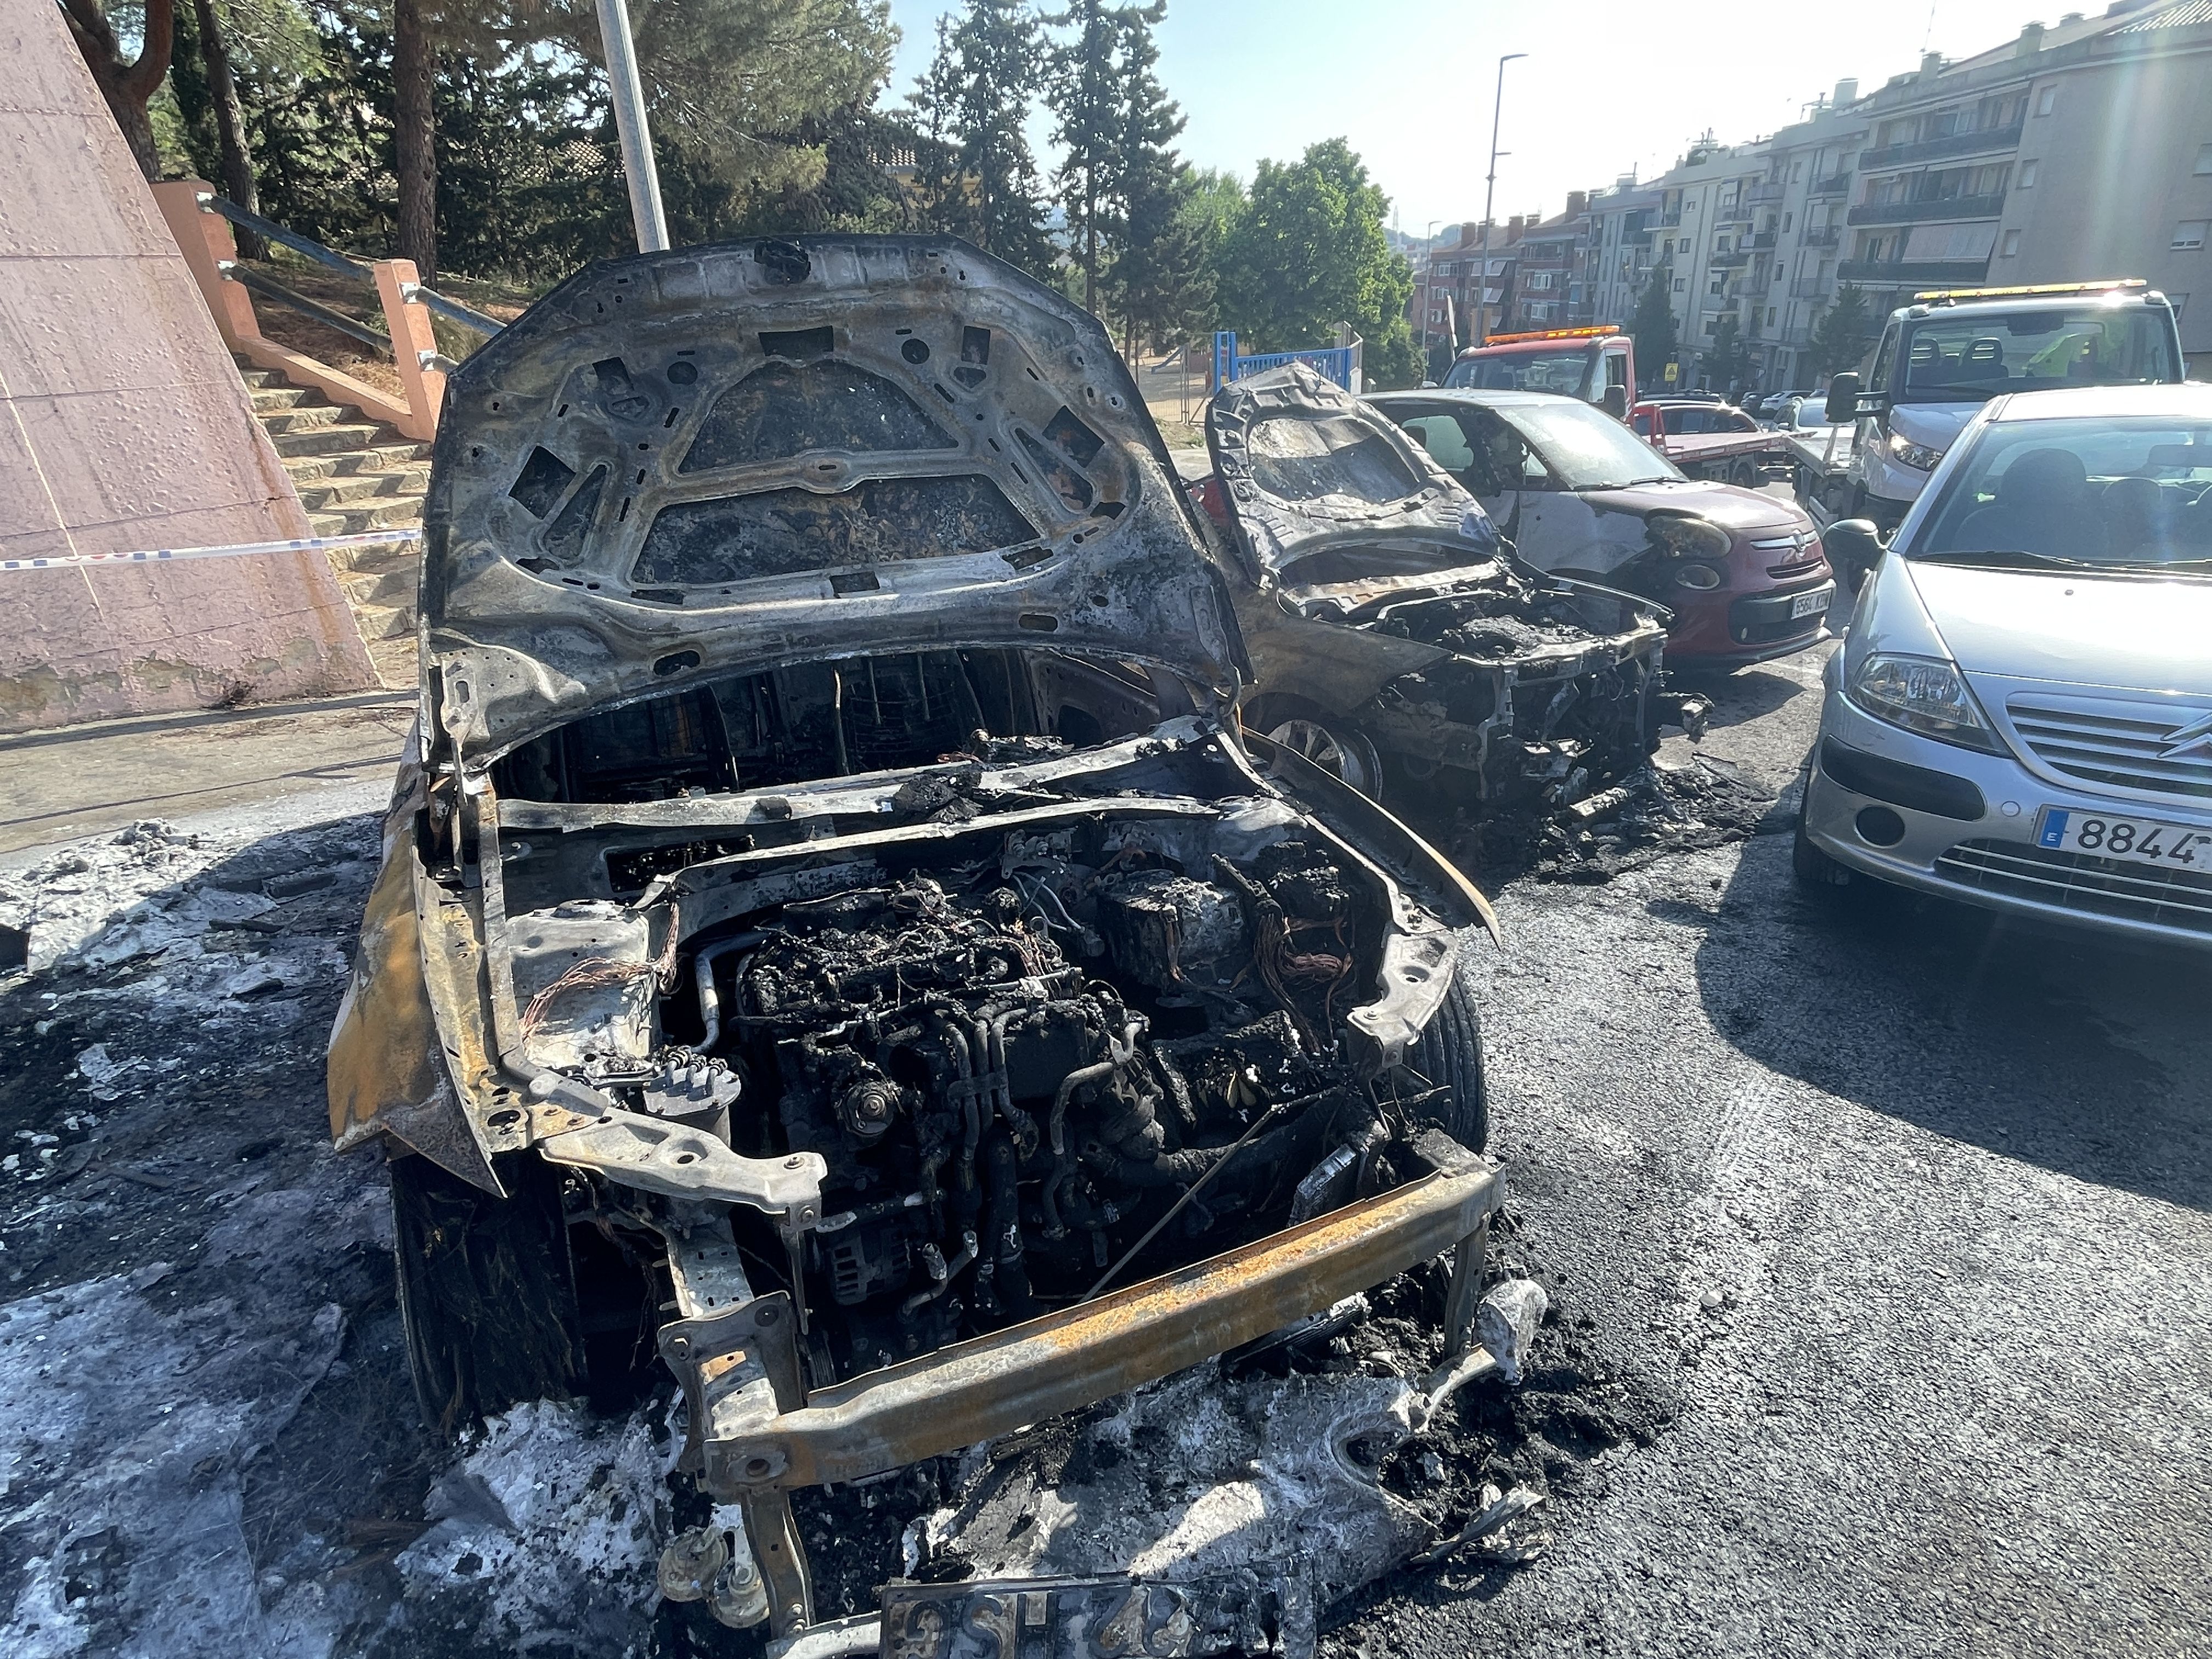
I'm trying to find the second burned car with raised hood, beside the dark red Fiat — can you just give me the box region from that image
[1203,363,1666,810]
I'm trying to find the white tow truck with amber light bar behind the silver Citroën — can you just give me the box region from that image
[1827,279,2186,533]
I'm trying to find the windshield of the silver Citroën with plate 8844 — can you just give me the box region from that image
[1905,416,2212,566]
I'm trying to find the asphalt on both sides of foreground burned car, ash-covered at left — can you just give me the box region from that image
[0,628,2212,1659]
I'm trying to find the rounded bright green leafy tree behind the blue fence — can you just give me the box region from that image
[1217,139,1420,385]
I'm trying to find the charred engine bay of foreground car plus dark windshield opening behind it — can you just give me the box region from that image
[498,652,1464,1387]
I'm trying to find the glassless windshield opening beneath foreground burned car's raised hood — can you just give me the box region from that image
[491,648,1188,803]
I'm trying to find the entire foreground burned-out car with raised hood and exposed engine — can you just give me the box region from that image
[330,236,1498,1652]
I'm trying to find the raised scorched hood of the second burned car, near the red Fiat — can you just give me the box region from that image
[1205,363,1498,579]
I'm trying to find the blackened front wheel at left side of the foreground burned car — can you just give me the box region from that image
[392,1155,586,1438]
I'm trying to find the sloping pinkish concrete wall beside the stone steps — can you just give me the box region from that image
[0,0,376,732]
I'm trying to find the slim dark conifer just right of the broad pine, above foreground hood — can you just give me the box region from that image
[911,0,1055,274]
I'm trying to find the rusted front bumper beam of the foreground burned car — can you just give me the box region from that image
[695,1130,1498,1504]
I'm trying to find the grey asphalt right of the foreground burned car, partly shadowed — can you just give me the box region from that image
[1336,654,2212,1659]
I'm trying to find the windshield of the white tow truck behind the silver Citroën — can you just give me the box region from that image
[1898,305,2181,403]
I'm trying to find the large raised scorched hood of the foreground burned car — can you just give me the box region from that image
[422,236,1241,763]
